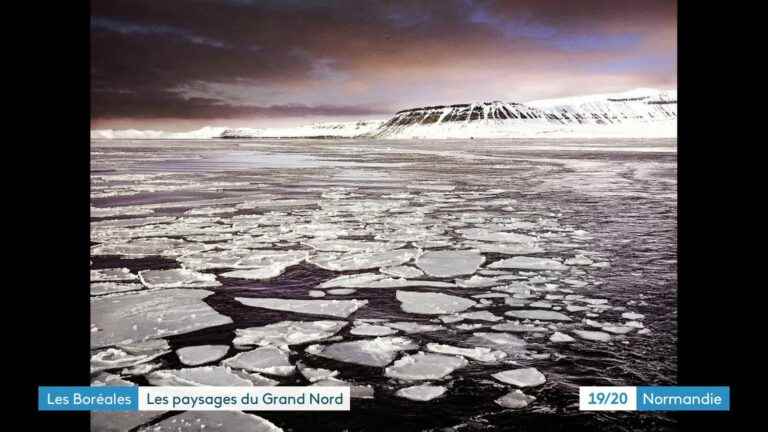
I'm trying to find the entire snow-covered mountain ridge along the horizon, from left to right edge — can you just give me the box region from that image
[91,88,677,139]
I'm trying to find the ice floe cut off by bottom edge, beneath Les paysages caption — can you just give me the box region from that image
[136,411,283,432]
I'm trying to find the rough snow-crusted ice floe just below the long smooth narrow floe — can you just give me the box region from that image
[232,321,347,347]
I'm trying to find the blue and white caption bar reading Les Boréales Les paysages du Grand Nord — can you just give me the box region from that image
[37,386,350,411]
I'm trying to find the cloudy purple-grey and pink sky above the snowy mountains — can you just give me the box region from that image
[90,0,677,131]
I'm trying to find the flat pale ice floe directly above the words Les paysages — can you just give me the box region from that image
[146,366,253,386]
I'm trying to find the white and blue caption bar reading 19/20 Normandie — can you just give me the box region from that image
[579,386,731,411]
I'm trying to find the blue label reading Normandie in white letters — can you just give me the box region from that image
[637,386,731,411]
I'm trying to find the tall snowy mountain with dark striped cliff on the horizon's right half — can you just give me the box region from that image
[370,89,677,138]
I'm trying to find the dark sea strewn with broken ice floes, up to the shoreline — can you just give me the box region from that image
[91,140,677,432]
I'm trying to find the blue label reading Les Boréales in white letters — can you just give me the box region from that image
[37,386,139,411]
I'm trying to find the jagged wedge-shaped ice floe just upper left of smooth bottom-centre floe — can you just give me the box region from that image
[307,336,418,367]
